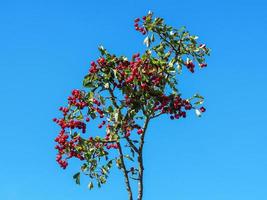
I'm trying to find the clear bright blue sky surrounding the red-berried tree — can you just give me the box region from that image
[0,0,267,200]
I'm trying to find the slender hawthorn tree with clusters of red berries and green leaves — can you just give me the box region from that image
[53,12,210,200]
